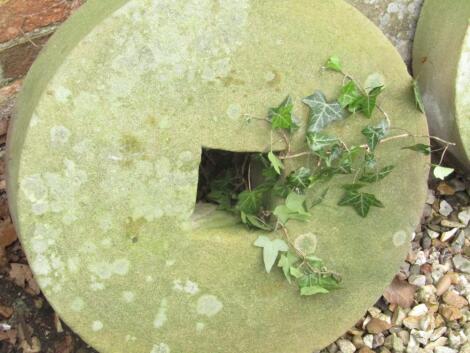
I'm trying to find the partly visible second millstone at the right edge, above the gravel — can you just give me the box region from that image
[413,0,470,170]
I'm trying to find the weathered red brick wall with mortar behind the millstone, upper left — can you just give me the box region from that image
[0,0,86,124]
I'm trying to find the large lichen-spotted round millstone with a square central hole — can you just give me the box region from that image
[8,0,428,353]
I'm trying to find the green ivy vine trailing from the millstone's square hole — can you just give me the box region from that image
[207,56,453,296]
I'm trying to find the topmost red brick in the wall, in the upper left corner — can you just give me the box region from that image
[0,0,85,43]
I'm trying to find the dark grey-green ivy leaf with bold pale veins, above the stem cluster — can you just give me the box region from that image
[303,91,345,132]
